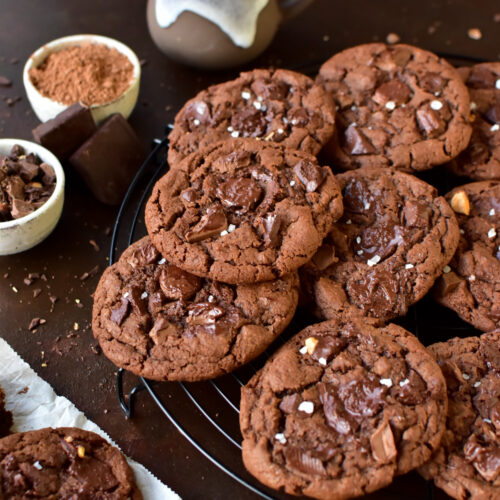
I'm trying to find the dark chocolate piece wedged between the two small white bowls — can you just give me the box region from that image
[32,103,97,160]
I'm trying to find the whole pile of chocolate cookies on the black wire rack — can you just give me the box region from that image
[93,44,500,499]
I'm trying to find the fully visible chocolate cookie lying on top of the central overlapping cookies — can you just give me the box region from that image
[145,139,342,283]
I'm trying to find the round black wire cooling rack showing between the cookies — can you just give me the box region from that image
[109,54,482,500]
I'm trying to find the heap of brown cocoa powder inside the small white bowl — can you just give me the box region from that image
[29,43,134,106]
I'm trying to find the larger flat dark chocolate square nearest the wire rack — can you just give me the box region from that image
[69,113,145,205]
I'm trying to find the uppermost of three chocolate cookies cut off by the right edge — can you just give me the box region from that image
[449,62,500,181]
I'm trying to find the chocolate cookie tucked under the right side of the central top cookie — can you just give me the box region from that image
[303,168,459,321]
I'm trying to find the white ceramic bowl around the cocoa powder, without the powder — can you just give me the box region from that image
[23,35,141,124]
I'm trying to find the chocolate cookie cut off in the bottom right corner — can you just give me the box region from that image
[420,330,500,500]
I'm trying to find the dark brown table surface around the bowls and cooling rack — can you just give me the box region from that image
[0,0,500,499]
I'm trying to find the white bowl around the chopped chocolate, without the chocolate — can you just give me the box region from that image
[0,139,64,255]
